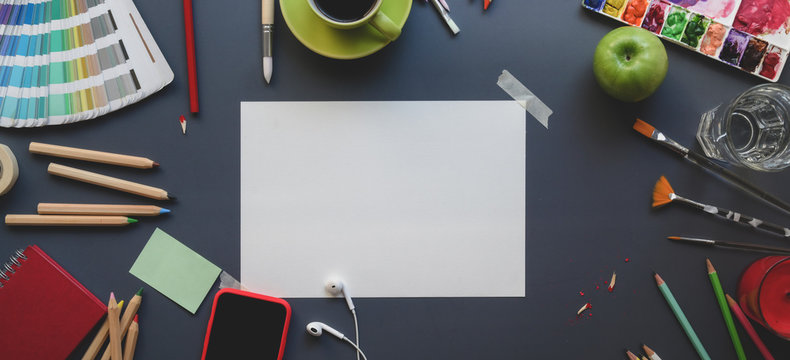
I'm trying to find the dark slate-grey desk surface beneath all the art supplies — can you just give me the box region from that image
[0,0,790,360]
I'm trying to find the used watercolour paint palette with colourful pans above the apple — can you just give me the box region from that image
[582,0,790,82]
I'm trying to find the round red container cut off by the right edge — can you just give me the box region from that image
[737,256,790,340]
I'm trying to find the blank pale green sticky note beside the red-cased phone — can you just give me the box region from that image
[129,228,221,314]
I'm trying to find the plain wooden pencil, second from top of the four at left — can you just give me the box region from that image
[47,163,175,200]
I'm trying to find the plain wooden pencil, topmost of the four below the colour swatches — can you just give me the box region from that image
[28,141,159,169]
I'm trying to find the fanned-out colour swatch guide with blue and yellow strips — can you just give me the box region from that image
[0,0,173,127]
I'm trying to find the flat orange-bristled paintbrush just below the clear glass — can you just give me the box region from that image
[634,119,790,214]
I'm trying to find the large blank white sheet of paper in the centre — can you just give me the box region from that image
[241,101,526,297]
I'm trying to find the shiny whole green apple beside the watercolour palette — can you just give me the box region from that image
[593,26,669,102]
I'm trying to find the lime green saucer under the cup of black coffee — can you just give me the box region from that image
[280,0,412,59]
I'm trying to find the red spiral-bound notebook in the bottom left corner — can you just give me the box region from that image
[0,245,107,360]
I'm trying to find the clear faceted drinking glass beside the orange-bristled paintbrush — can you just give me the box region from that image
[697,84,790,171]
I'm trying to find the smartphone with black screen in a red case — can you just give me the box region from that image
[203,289,291,360]
